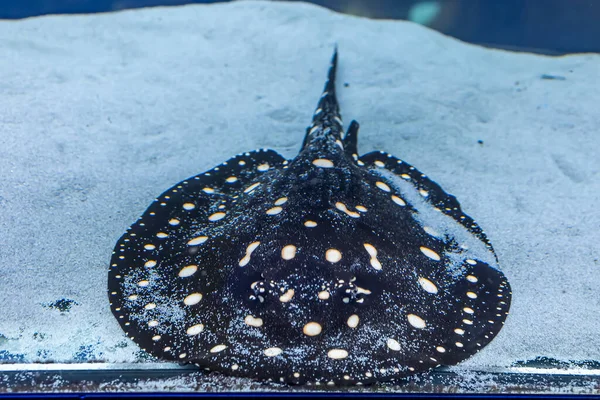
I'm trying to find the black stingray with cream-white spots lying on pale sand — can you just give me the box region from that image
[108,50,511,385]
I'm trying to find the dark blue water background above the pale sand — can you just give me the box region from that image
[0,0,600,54]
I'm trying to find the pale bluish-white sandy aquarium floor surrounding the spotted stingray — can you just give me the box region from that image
[0,1,600,391]
